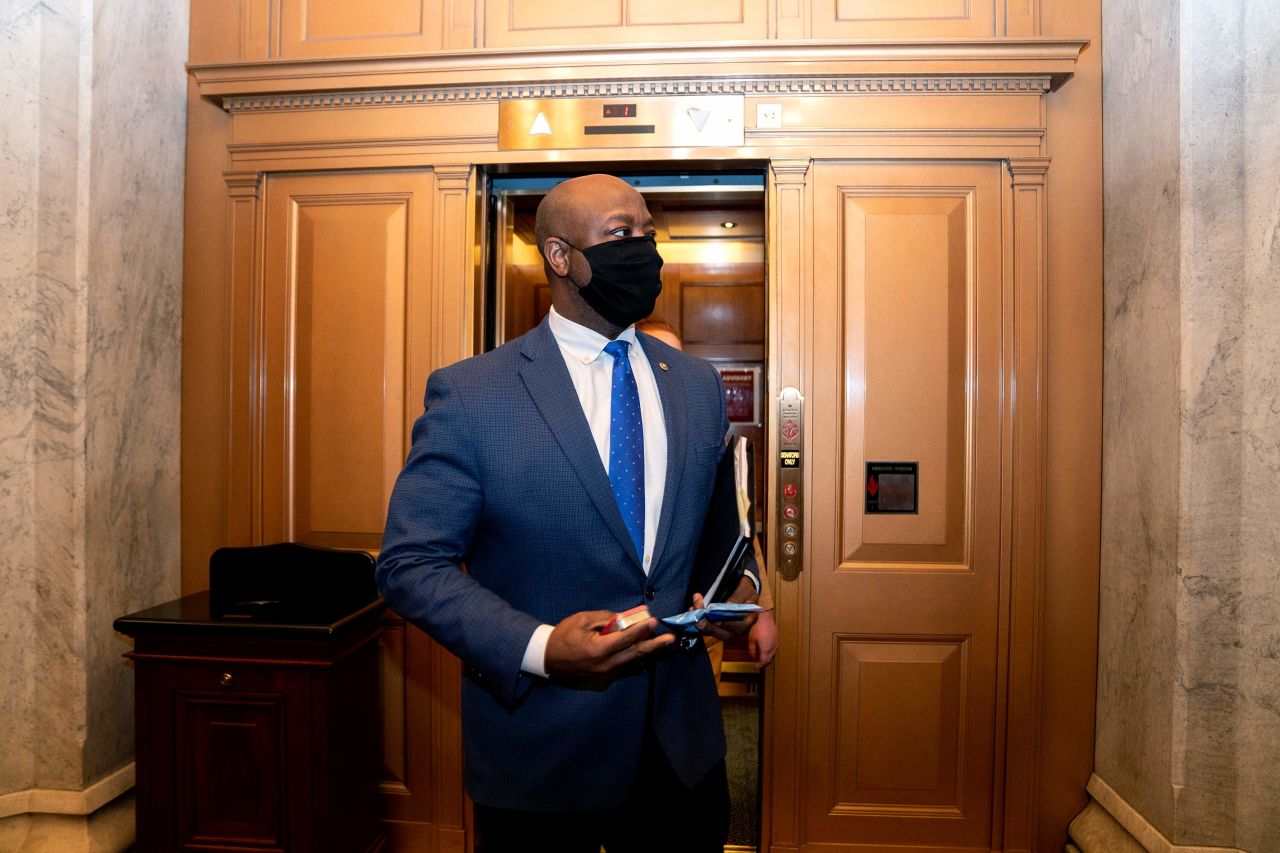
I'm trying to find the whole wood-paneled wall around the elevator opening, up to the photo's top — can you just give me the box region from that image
[183,0,1101,850]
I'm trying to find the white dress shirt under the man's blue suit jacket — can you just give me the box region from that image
[521,307,667,676]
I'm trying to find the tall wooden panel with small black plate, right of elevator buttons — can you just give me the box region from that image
[797,164,1006,850]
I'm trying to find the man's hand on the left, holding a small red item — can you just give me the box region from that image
[545,610,676,678]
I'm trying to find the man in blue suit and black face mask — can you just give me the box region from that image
[378,175,754,853]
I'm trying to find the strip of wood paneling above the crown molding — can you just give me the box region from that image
[191,0,1041,63]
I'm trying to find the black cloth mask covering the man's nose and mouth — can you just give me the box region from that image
[561,234,662,329]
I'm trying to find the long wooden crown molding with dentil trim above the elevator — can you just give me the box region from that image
[188,38,1088,111]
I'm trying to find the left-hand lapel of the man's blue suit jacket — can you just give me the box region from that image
[520,320,645,573]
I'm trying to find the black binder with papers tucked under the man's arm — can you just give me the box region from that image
[689,435,755,605]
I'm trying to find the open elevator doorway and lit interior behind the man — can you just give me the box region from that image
[481,169,771,850]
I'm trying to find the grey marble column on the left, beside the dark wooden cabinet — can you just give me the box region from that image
[0,0,187,852]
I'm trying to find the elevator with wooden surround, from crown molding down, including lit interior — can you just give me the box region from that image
[183,23,1098,853]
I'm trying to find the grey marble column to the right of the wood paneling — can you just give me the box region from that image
[1091,0,1280,852]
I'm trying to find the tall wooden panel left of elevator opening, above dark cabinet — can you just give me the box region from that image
[261,173,431,549]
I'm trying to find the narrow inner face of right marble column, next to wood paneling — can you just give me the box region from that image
[1096,0,1180,822]
